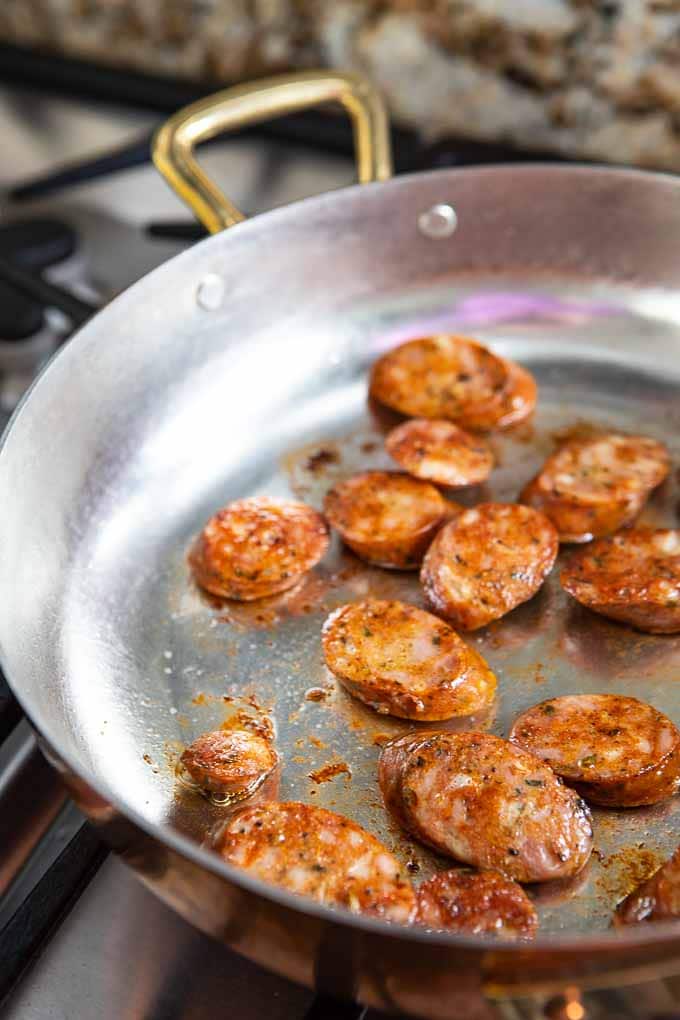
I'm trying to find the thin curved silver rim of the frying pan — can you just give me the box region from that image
[0,161,680,954]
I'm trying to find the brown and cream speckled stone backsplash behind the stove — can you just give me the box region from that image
[0,0,680,170]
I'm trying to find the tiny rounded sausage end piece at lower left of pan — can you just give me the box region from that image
[179,729,278,801]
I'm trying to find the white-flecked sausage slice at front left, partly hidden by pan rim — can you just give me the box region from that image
[217,802,415,924]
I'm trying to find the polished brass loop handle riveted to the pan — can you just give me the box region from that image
[151,70,391,234]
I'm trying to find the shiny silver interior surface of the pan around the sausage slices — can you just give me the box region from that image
[0,170,680,934]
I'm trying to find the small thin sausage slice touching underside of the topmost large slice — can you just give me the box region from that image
[385,418,493,486]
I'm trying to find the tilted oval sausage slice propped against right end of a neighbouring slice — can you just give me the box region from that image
[420,503,558,630]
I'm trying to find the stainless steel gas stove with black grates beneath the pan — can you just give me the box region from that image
[0,73,680,1020]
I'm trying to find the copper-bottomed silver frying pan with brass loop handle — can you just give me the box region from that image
[0,71,680,1017]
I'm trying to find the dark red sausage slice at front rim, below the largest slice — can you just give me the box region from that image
[416,868,538,938]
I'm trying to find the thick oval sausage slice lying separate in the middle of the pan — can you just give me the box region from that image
[323,599,495,720]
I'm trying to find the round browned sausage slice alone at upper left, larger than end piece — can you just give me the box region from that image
[190,497,328,602]
